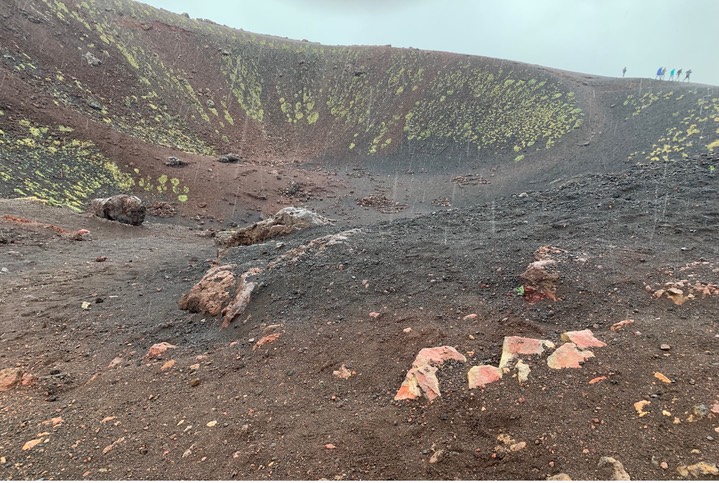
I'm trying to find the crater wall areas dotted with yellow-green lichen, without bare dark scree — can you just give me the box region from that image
[0,0,717,213]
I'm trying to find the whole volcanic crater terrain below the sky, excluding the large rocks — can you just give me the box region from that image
[0,0,719,480]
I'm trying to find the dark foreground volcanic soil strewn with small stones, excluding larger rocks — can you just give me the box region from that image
[0,152,719,480]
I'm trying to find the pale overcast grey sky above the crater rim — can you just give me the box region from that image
[142,0,719,85]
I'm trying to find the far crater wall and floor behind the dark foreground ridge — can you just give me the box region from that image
[0,0,719,224]
